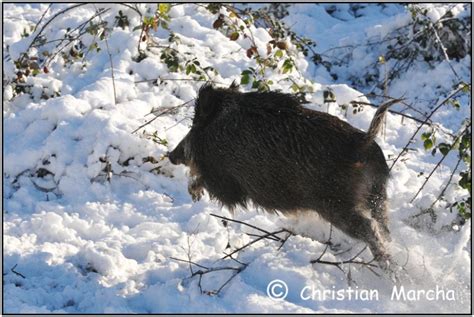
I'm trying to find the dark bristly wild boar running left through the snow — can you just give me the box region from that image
[169,85,398,260]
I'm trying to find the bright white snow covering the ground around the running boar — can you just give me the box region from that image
[3,4,471,313]
